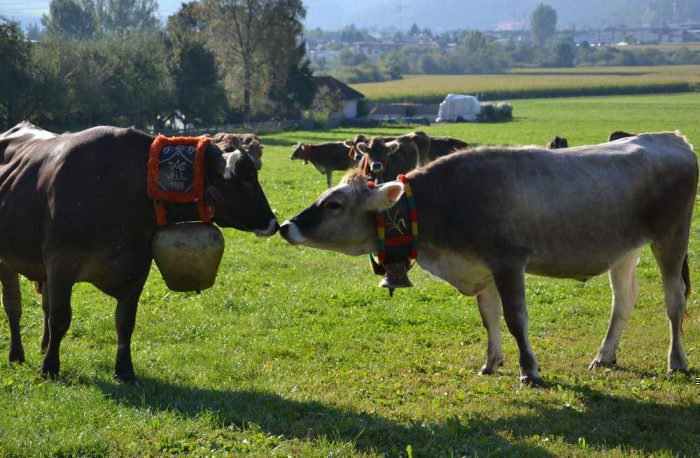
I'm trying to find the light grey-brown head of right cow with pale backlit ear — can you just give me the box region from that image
[280,172,403,255]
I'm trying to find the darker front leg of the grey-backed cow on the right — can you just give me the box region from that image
[493,263,544,385]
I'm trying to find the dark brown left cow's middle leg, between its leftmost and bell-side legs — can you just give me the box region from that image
[41,269,74,377]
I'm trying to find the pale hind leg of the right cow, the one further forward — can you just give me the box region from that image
[588,248,642,369]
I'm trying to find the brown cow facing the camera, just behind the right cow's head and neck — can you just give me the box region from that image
[355,132,430,182]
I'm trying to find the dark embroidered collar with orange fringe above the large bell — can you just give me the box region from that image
[148,135,214,226]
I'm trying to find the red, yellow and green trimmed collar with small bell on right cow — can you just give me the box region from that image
[367,175,418,296]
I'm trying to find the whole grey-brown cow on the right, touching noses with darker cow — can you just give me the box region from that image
[280,133,698,384]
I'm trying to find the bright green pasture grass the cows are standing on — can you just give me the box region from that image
[0,93,700,457]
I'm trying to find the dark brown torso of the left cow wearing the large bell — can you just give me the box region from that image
[0,127,155,278]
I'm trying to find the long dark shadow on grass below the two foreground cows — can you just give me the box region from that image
[91,379,700,456]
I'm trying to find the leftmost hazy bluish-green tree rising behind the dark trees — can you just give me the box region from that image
[41,0,97,39]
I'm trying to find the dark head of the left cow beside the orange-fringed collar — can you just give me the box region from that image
[206,144,279,236]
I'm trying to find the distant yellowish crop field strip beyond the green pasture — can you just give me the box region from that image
[352,65,700,103]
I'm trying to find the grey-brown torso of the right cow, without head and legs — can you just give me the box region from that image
[411,133,697,278]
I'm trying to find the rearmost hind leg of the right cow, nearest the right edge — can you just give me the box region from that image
[651,242,690,372]
